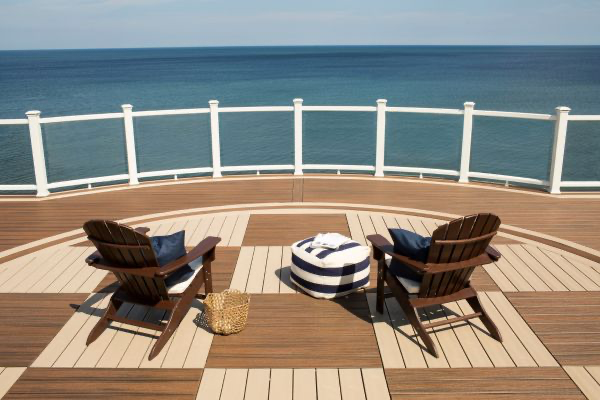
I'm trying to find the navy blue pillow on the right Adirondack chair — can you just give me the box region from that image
[388,228,431,281]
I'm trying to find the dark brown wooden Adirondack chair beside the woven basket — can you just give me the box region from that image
[83,220,221,360]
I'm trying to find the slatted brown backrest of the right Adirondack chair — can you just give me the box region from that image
[419,214,500,297]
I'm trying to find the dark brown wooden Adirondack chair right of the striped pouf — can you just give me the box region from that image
[367,214,502,357]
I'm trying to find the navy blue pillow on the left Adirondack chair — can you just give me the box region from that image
[150,231,194,287]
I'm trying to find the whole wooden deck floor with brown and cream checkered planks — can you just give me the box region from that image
[0,177,600,400]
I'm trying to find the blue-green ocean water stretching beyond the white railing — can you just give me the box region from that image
[0,46,600,184]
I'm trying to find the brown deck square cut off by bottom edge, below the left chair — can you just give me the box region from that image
[4,368,202,400]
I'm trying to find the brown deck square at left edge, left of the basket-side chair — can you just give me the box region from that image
[0,293,88,367]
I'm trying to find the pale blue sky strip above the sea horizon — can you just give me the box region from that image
[0,0,600,49]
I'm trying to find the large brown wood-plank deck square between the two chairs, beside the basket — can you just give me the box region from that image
[206,293,381,368]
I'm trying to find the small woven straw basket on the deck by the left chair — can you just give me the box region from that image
[204,289,250,335]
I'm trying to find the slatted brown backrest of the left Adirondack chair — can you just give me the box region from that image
[83,220,169,300]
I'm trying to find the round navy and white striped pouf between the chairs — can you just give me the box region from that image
[291,237,371,299]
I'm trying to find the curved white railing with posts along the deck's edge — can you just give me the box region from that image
[0,99,600,196]
